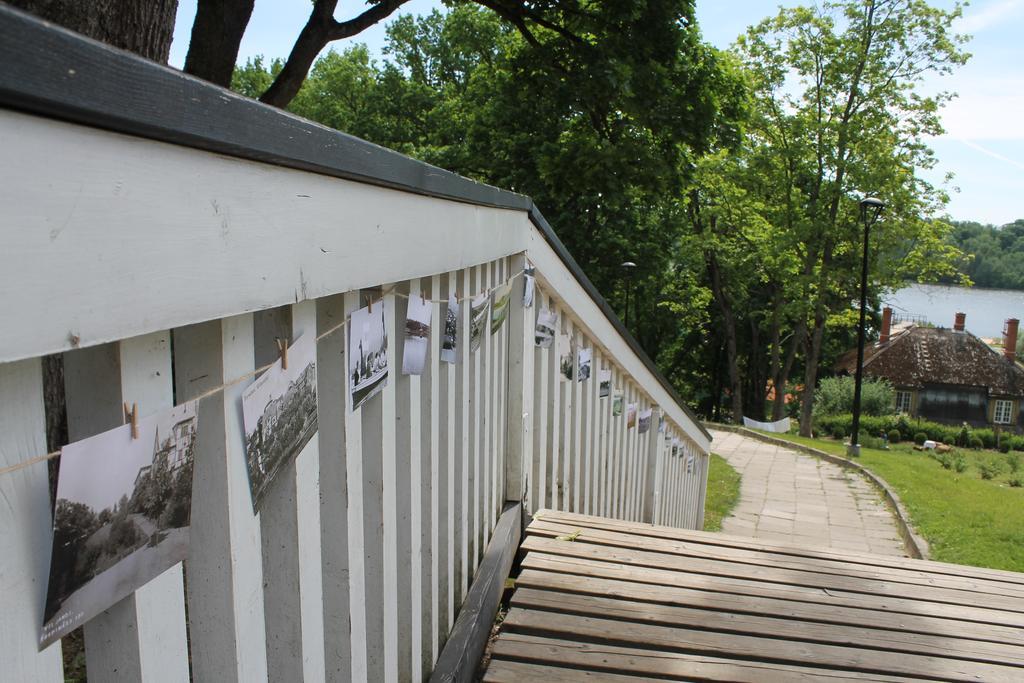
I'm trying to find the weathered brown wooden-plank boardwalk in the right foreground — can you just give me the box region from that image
[484,510,1024,683]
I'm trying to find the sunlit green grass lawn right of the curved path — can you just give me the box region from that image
[770,434,1024,571]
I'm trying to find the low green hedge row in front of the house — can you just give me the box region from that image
[814,415,1024,453]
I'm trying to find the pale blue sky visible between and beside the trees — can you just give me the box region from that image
[170,0,1024,224]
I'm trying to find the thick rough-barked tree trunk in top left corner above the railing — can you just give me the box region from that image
[7,0,178,63]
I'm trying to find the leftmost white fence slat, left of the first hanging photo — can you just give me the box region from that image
[0,358,63,683]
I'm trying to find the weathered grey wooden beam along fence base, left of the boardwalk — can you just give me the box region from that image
[430,503,522,683]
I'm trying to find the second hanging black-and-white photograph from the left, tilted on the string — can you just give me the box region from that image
[242,335,317,510]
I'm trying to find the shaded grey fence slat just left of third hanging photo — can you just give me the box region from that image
[316,295,352,681]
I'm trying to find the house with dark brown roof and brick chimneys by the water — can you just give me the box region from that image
[836,308,1024,431]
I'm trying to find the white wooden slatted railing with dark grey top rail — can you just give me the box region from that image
[0,7,710,682]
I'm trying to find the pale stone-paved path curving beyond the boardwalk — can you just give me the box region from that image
[712,431,906,556]
